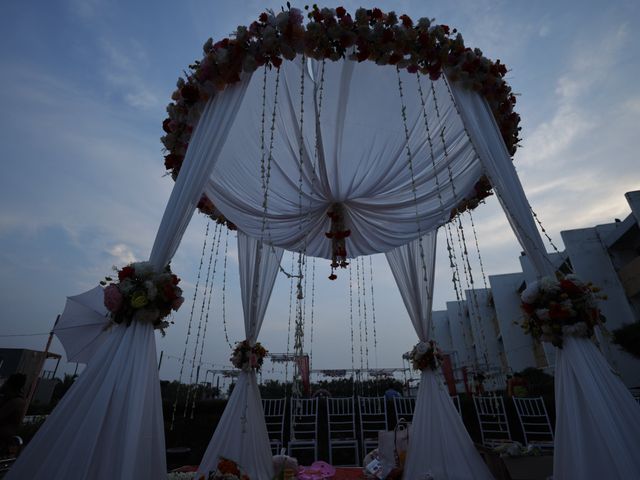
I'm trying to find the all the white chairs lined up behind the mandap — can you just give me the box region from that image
[262,395,553,465]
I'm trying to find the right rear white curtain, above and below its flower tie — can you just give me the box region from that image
[387,230,493,480]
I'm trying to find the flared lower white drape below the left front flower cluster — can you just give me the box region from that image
[6,323,167,480]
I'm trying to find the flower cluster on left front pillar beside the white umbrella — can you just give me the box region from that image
[100,262,184,333]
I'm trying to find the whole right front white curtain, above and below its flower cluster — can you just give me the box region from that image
[451,80,640,480]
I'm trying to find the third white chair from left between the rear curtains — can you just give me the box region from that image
[327,397,360,466]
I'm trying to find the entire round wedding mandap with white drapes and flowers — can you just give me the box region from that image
[7,6,640,480]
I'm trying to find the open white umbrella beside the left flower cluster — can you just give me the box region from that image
[53,286,110,363]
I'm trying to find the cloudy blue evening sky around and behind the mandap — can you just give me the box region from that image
[0,0,640,379]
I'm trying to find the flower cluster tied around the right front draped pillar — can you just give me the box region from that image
[520,275,606,348]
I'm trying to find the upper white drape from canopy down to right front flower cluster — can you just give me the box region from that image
[450,83,555,276]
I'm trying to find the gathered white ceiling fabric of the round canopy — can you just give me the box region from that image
[206,58,482,258]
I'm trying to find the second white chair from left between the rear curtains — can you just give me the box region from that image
[287,397,318,463]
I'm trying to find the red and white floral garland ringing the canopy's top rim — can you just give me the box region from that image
[162,5,520,224]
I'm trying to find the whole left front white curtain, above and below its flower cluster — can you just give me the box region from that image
[6,77,254,480]
